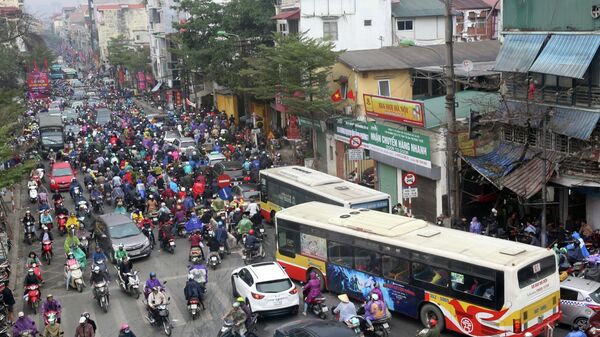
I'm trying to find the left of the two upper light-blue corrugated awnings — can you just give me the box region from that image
[494,34,546,73]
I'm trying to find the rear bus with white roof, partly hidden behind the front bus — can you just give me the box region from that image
[260,166,392,221]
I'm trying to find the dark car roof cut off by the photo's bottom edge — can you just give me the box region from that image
[273,320,356,337]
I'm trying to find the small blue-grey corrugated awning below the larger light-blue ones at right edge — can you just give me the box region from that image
[549,108,600,140]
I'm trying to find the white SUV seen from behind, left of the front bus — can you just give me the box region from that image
[231,262,300,316]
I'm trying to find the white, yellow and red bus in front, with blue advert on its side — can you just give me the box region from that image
[275,202,560,336]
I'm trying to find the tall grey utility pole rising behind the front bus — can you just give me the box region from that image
[440,0,461,223]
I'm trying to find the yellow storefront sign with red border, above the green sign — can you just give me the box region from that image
[364,94,425,127]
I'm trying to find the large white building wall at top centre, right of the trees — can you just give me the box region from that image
[300,0,392,50]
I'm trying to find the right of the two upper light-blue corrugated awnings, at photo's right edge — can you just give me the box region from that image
[529,35,600,79]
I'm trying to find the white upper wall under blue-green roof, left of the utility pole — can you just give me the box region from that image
[394,16,446,45]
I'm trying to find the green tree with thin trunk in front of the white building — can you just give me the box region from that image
[241,34,339,158]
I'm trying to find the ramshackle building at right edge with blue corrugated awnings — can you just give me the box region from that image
[476,0,600,228]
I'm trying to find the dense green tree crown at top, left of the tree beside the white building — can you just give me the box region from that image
[172,0,275,90]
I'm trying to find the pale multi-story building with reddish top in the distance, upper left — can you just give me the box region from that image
[94,0,150,60]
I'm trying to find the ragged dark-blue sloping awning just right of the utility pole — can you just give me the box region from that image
[462,142,535,188]
